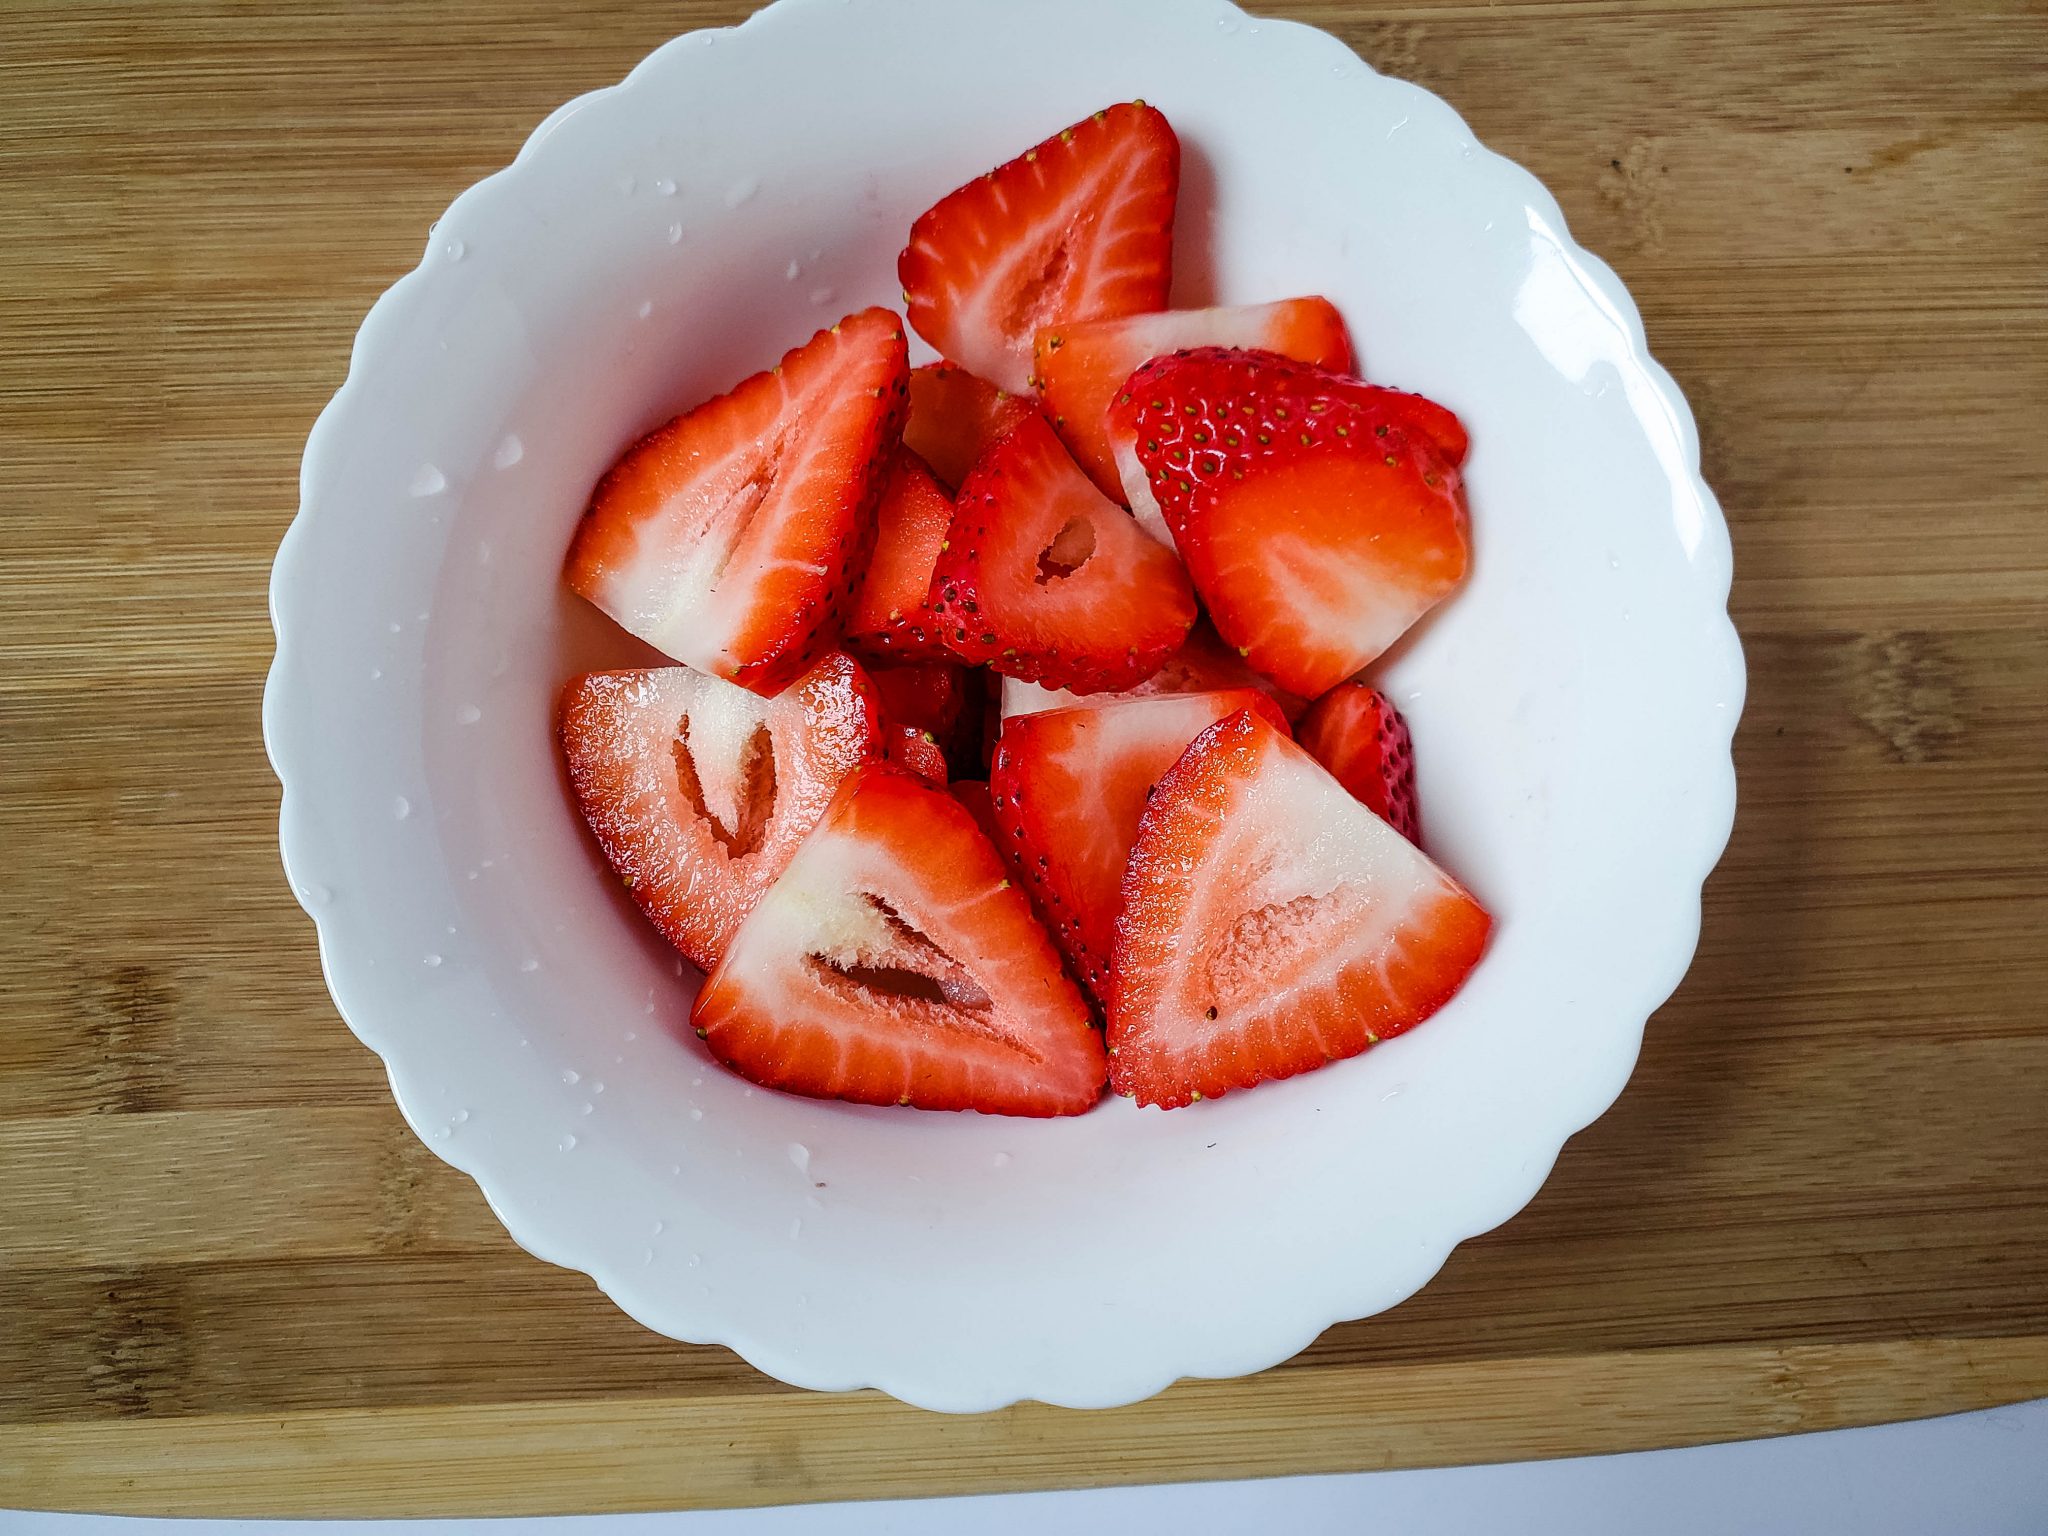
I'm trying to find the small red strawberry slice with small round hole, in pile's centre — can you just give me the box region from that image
[932,416,1196,692]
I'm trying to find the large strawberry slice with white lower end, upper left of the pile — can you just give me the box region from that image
[567,309,909,694]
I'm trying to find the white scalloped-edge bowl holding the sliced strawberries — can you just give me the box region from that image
[264,0,1743,1409]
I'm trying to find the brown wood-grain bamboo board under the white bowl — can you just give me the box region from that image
[0,0,2048,1513]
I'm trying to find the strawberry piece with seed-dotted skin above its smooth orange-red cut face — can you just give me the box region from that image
[1110,348,1468,698]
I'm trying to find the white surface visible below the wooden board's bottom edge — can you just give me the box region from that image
[0,1399,2048,1536]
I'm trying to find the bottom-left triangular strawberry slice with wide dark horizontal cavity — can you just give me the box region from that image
[692,764,1104,1116]
